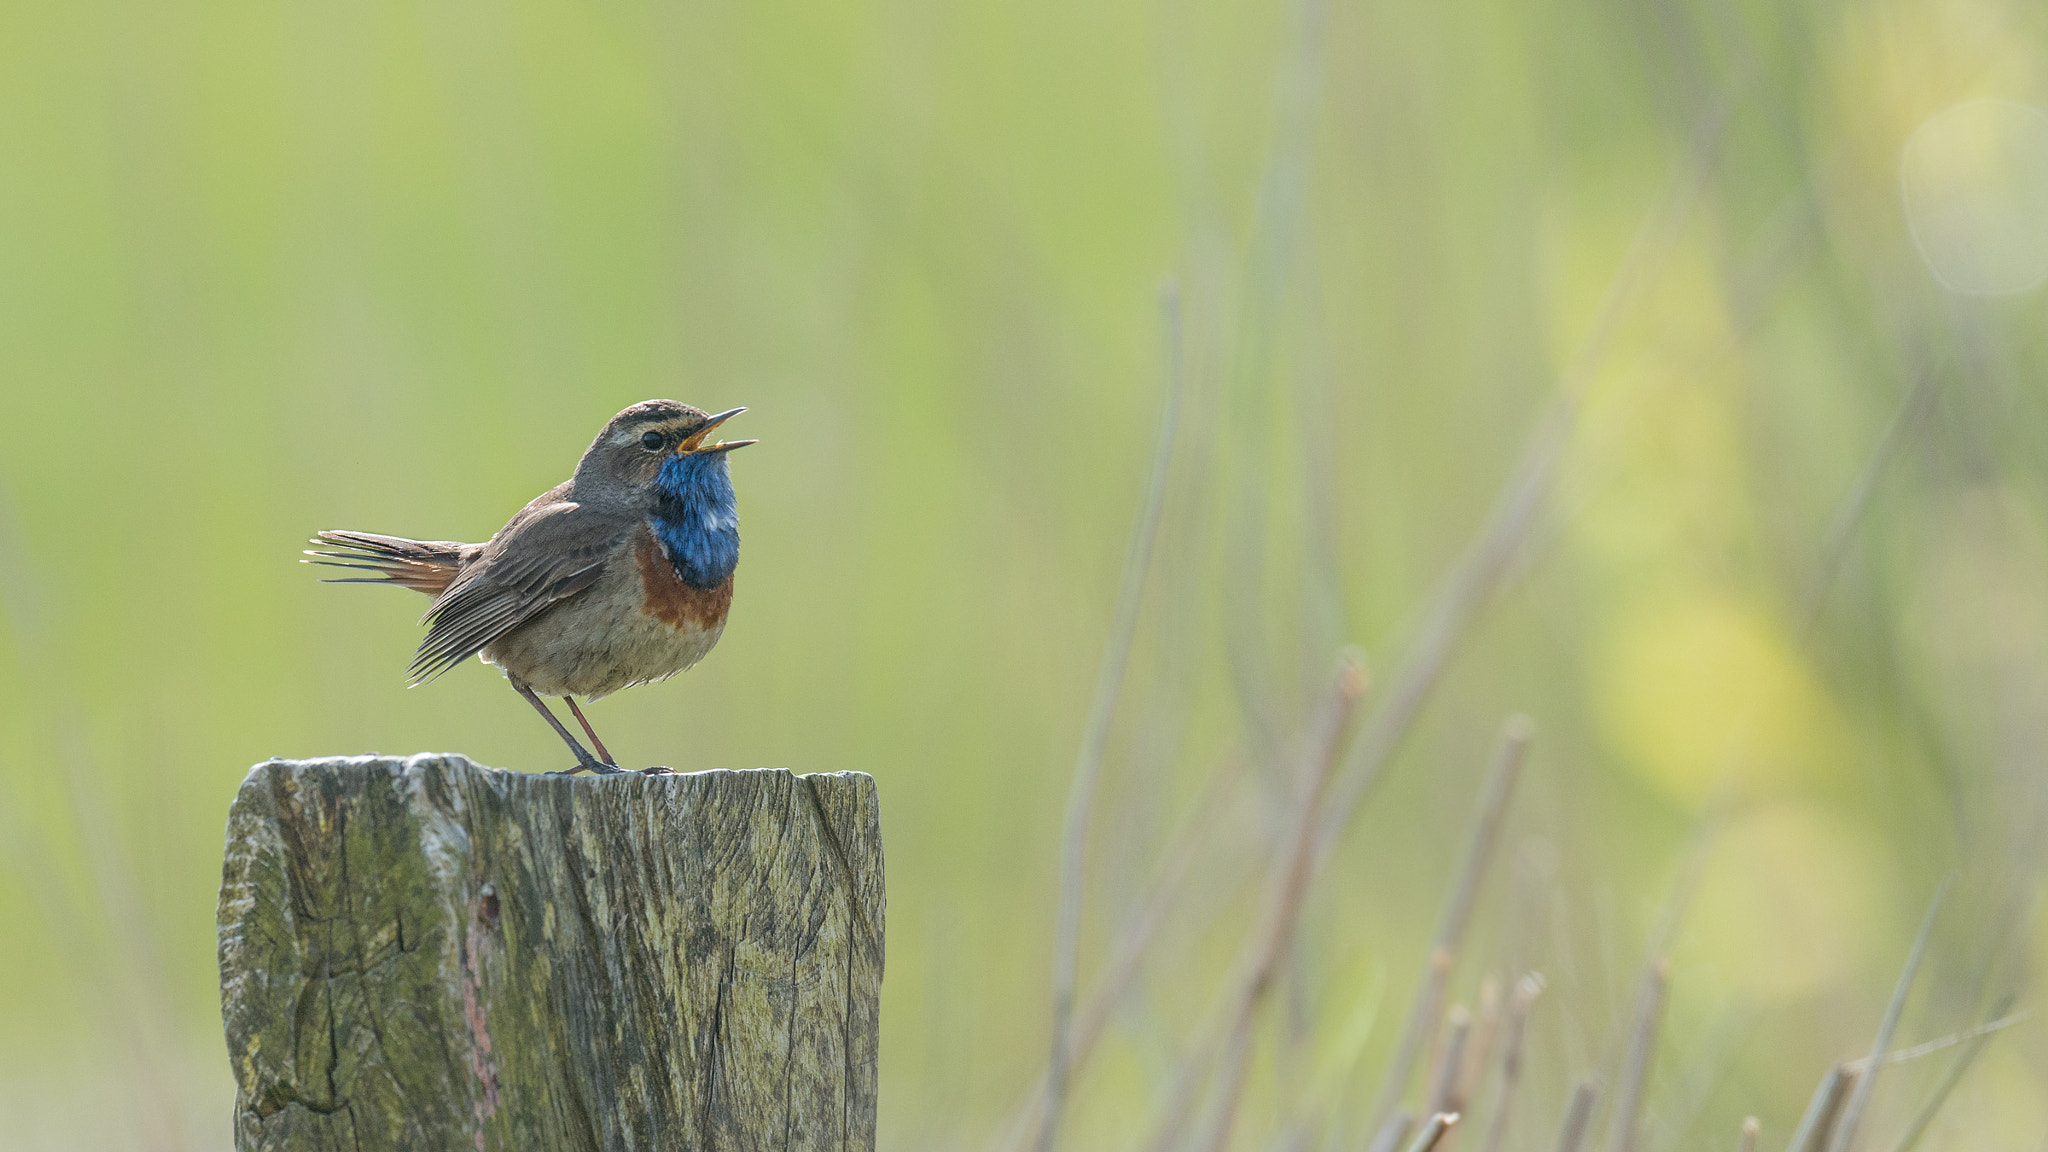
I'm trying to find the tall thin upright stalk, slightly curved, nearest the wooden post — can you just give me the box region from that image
[1038,285,1182,1152]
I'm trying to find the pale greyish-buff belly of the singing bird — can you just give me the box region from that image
[481,564,725,699]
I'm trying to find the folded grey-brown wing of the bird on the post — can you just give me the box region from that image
[408,490,637,685]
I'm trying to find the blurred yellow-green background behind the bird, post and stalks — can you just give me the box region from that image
[0,0,2048,1150]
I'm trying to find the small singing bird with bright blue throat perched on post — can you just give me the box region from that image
[307,400,756,775]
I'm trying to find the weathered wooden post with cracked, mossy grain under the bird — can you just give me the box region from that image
[219,754,883,1152]
